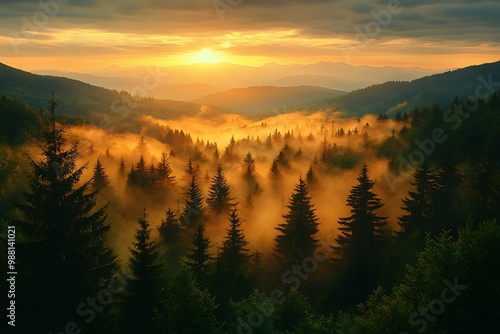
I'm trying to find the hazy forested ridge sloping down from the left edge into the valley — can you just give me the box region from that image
[0,63,228,126]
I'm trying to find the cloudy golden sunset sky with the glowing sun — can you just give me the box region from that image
[0,0,500,70]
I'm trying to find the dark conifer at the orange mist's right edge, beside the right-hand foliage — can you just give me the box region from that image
[398,163,433,241]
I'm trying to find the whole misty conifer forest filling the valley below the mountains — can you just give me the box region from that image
[0,85,500,334]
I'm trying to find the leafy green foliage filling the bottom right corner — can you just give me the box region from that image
[336,222,500,334]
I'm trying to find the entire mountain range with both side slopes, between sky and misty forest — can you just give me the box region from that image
[0,61,500,122]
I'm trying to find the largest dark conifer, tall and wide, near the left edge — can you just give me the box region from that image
[13,97,118,333]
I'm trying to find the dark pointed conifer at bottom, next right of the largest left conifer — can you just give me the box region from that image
[120,209,166,334]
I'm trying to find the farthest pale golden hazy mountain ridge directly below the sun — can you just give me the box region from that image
[66,62,439,92]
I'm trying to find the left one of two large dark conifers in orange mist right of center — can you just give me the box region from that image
[275,177,318,265]
